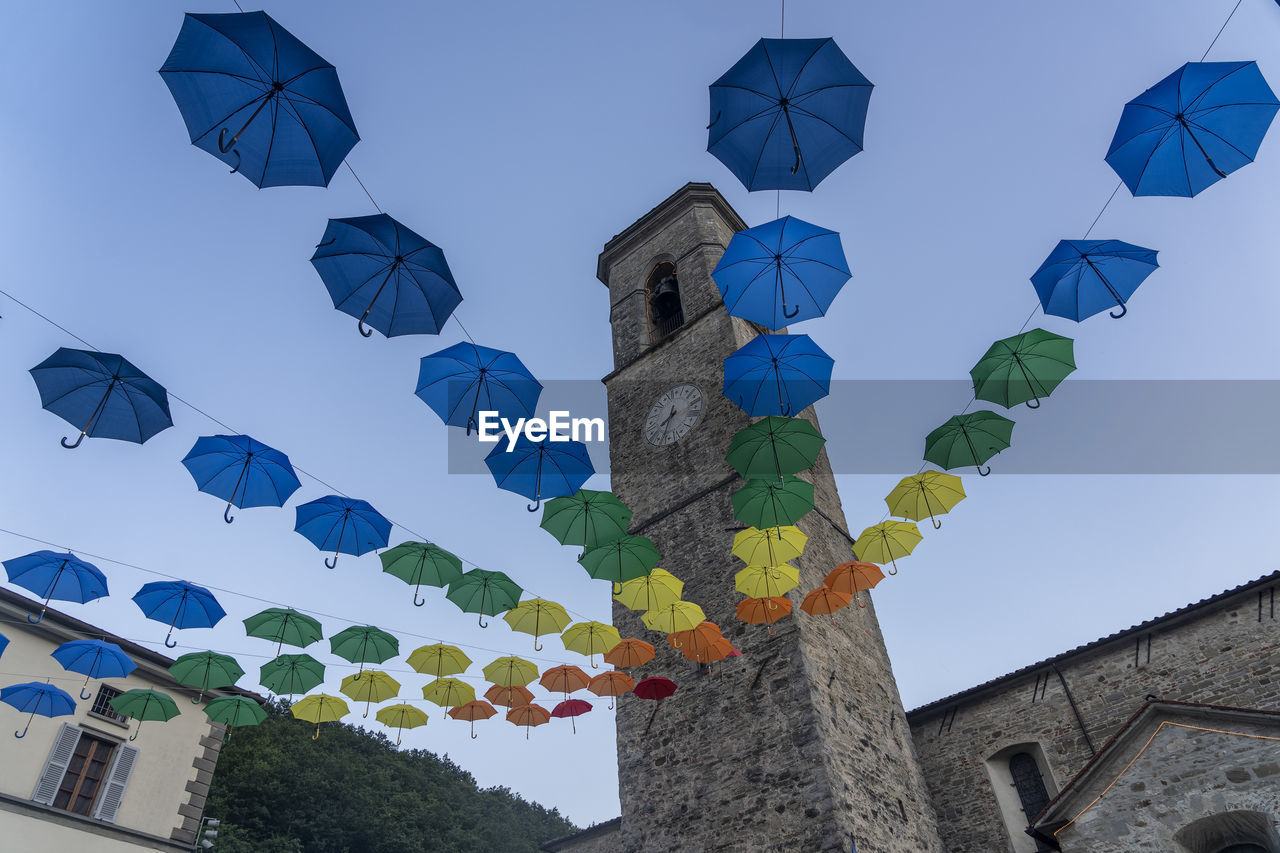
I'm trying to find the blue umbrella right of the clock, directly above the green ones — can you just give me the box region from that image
[724,334,835,418]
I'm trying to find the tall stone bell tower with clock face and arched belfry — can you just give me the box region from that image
[596,183,943,853]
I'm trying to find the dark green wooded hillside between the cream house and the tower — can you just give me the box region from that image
[205,702,576,853]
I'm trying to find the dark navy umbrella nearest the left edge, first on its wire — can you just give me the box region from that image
[29,347,173,448]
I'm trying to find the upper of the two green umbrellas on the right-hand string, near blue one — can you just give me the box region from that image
[969,329,1075,409]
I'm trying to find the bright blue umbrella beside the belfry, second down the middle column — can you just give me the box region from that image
[712,216,849,329]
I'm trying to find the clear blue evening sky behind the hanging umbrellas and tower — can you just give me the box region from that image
[0,0,1280,824]
